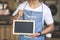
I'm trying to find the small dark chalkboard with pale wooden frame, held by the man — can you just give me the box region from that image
[13,20,35,35]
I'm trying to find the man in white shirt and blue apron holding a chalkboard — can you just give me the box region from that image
[13,0,54,40]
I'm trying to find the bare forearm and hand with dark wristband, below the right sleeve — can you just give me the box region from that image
[29,23,54,38]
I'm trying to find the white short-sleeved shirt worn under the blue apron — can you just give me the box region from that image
[13,1,53,25]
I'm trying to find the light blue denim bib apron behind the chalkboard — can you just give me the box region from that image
[18,10,44,40]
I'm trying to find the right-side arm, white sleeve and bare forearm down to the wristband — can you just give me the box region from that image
[41,5,54,34]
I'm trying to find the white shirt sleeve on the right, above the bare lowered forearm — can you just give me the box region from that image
[44,6,54,25]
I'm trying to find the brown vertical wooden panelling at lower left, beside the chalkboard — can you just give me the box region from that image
[0,25,18,40]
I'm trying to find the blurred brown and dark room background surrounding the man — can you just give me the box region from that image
[0,0,60,40]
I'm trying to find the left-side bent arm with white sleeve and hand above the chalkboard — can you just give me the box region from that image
[13,1,27,19]
